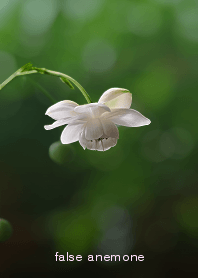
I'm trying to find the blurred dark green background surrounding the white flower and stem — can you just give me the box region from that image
[0,0,198,278]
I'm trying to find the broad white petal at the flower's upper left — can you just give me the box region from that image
[45,100,78,120]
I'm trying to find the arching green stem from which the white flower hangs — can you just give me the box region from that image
[0,63,92,103]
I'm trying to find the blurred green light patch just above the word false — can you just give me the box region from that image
[46,207,97,255]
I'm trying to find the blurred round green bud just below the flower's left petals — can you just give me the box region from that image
[49,141,75,165]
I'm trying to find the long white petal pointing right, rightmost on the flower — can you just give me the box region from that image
[103,109,151,127]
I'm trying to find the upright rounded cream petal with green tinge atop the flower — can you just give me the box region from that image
[98,88,132,109]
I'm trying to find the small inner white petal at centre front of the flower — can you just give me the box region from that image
[85,118,103,140]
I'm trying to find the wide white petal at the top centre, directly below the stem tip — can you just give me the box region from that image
[74,103,111,118]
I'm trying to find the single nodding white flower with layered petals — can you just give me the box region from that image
[44,88,151,151]
